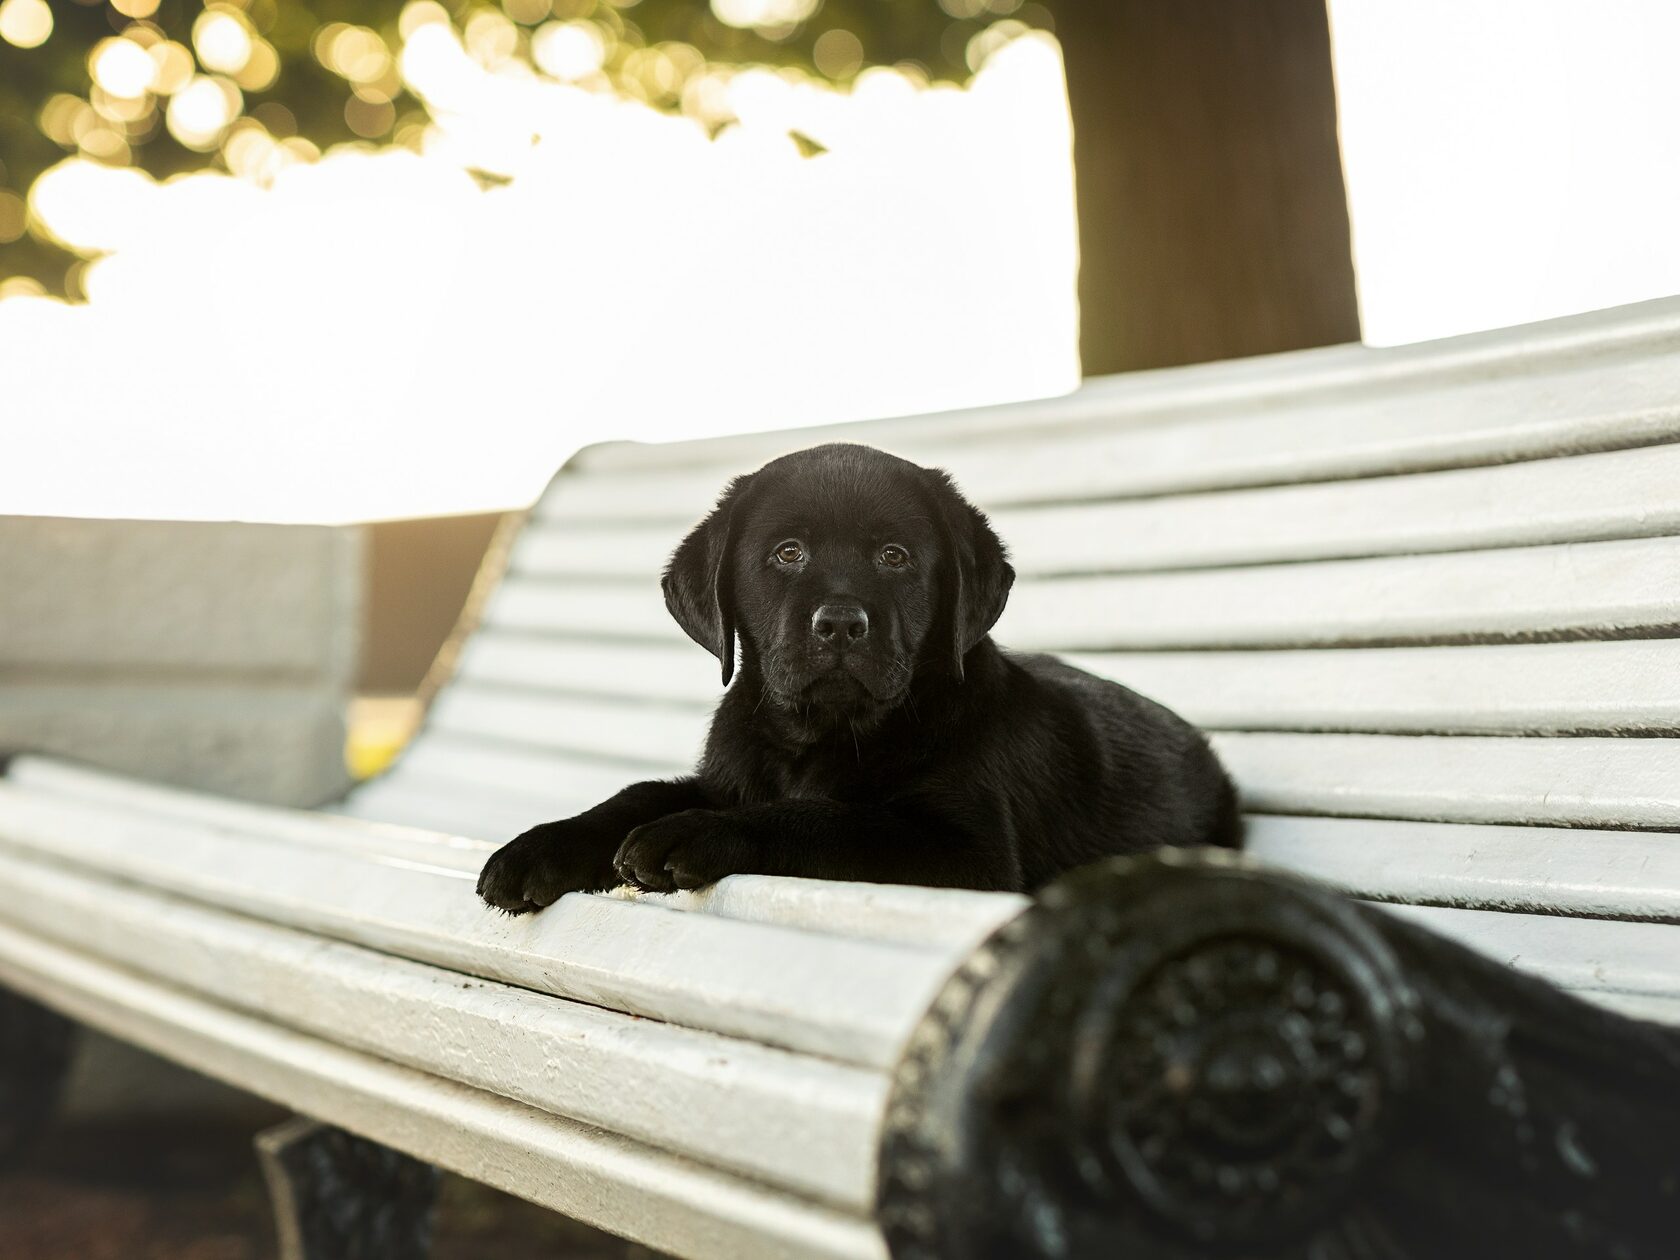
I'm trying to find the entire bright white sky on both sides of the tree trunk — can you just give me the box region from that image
[0,0,1680,521]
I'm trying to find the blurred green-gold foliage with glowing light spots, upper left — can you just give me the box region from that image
[0,0,1052,296]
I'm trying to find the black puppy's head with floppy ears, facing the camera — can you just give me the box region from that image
[664,444,1015,719]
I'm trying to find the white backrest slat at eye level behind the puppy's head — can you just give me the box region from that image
[511,445,1680,581]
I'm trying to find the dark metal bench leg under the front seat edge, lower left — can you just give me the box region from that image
[257,1117,438,1260]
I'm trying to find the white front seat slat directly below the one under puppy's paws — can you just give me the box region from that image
[0,848,887,1211]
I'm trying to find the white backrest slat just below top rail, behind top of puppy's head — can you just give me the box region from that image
[536,337,1680,522]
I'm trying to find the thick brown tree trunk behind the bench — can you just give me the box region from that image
[1053,0,1359,376]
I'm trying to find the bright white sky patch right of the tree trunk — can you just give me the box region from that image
[1329,0,1680,344]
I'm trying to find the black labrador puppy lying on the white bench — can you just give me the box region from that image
[479,445,1240,914]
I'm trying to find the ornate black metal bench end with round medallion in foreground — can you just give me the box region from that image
[877,855,1680,1260]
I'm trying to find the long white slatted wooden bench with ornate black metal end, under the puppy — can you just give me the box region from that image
[0,302,1680,1260]
